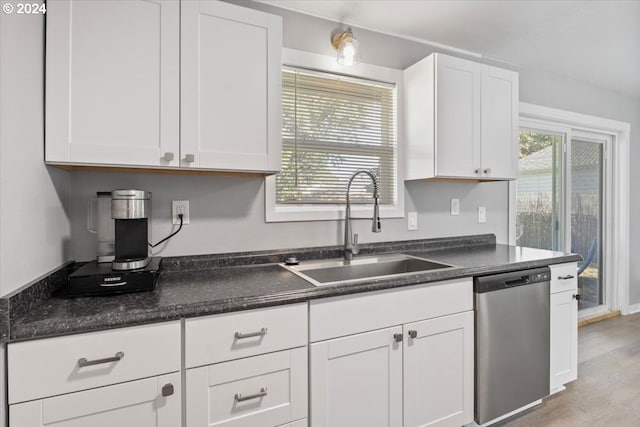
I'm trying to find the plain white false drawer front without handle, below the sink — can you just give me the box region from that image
[309,278,473,342]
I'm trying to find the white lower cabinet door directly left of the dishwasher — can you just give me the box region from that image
[404,311,474,427]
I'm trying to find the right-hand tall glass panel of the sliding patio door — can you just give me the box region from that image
[571,139,604,309]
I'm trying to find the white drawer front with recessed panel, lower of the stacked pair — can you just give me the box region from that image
[186,347,307,427]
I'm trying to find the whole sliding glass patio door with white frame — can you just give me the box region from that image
[516,125,610,311]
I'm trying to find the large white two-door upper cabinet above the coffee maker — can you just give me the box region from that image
[45,0,282,173]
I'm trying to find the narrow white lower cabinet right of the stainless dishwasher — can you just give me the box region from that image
[549,263,579,393]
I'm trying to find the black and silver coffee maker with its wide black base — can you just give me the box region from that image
[67,190,161,296]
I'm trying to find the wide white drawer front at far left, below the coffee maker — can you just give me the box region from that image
[7,321,180,404]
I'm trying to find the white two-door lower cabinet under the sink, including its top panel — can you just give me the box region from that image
[309,279,474,427]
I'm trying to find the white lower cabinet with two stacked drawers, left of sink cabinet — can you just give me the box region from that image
[185,303,308,427]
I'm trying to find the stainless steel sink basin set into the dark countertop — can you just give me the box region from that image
[281,254,454,286]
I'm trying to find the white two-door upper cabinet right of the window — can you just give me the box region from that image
[404,54,518,180]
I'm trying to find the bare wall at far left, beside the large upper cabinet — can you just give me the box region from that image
[0,4,70,295]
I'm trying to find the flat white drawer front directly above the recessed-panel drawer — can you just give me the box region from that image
[185,303,307,368]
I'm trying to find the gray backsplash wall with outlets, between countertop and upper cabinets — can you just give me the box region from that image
[70,172,508,260]
